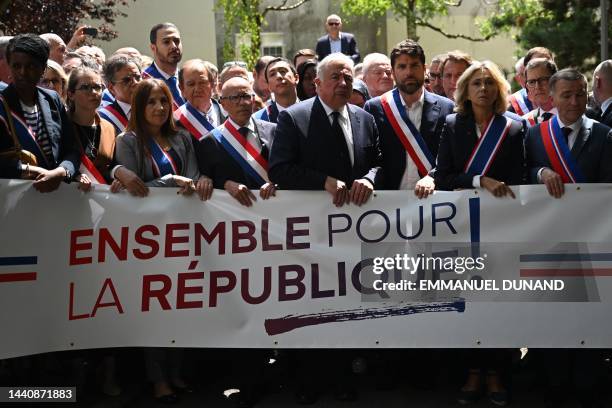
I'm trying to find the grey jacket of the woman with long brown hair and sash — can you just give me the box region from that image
[115,129,200,187]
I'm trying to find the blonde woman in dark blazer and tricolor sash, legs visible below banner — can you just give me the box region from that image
[434,61,524,406]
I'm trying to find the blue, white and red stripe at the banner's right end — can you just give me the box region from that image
[520,252,612,278]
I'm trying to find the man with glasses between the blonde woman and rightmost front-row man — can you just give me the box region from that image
[523,58,557,127]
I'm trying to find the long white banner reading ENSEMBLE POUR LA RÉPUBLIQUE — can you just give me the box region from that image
[0,180,612,358]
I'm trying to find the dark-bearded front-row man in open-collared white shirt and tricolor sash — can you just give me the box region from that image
[364,40,454,198]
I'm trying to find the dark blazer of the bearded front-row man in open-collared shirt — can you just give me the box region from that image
[363,90,455,190]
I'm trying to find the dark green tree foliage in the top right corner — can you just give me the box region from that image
[480,0,612,71]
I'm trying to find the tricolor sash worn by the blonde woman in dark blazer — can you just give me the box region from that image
[464,115,512,176]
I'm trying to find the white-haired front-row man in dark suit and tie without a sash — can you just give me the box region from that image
[270,53,381,206]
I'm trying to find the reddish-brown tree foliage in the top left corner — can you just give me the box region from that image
[0,0,135,41]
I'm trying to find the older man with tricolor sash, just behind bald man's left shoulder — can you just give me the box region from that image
[174,59,225,140]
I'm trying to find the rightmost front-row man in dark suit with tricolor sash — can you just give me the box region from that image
[526,69,612,198]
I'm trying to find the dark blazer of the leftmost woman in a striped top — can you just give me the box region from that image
[0,85,80,178]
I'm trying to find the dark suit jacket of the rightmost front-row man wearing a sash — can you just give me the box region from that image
[526,116,612,184]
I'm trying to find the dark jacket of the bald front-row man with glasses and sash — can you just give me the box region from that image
[196,119,276,190]
